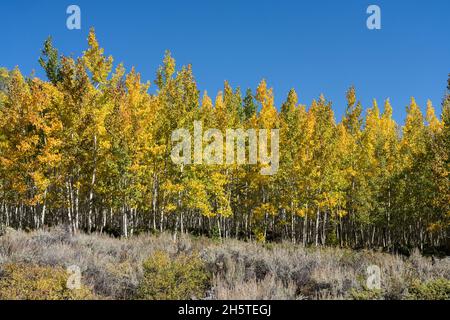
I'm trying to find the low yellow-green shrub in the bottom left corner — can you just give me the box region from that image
[0,264,94,300]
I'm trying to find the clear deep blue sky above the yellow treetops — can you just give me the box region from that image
[0,0,450,122]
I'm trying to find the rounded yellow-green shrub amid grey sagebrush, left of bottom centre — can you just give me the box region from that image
[138,251,210,300]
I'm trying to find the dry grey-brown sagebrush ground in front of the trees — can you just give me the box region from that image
[0,228,450,300]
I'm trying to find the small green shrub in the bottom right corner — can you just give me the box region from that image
[407,278,450,300]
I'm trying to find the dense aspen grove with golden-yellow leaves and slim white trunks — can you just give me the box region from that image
[0,29,450,249]
